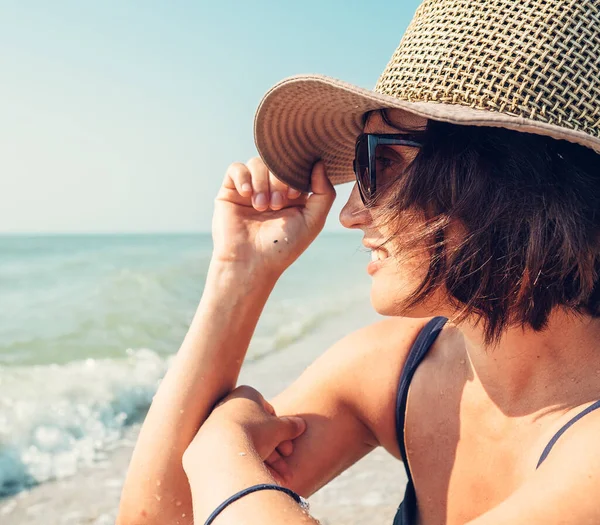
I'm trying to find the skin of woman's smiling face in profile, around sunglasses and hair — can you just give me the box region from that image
[340,110,440,317]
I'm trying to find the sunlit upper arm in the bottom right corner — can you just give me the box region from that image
[468,411,600,525]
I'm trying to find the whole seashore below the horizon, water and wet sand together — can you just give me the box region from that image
[0,234,406,525]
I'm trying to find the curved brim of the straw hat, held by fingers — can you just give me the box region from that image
[254,75,600,192]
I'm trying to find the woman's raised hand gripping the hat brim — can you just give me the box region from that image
[212,157,335,278]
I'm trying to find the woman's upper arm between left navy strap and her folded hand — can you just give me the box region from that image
[270,318,424,497]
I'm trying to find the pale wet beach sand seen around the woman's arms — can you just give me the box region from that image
[0,305,406,525]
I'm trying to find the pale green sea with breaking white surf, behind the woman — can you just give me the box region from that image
[0,232,369,498]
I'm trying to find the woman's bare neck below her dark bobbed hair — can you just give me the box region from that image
[459,310,600,415]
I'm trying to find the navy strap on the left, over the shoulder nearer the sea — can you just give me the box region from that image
[396,317,448,480]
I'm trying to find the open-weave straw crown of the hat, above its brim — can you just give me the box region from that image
[375,0,600,137]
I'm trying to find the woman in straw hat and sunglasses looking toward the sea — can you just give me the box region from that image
[119,0,600,525]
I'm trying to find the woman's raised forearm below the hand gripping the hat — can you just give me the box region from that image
[119,263,274,525]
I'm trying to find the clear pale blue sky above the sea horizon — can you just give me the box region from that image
[0,0,419,232]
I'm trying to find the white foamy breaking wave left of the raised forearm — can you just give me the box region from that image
[0,350,168,496]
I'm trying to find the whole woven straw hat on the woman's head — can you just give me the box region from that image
[254,0,600,191]
